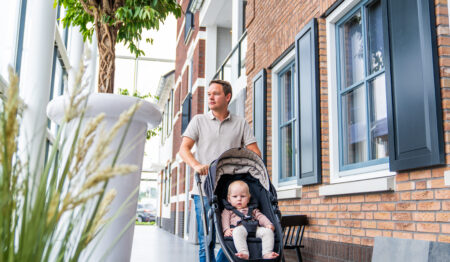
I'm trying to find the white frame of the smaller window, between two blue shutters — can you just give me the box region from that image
[272,48,302,199]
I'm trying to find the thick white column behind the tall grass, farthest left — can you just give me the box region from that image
[19,0,56,171]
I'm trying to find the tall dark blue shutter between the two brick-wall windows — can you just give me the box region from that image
[295,19,322,185]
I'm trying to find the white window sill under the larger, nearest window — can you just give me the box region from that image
[319,176,395,196]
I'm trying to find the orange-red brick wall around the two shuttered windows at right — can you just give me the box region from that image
[246,0,450,246]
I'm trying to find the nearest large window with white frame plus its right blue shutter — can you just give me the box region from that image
[326,0,445,189]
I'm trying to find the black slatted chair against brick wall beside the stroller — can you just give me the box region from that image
[281,215,308,262]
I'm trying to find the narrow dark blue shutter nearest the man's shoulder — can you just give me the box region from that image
[253,69,266,163]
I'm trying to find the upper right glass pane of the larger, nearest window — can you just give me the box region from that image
[367,1,384,74]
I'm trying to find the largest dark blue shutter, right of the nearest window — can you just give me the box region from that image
[382,0,445,171]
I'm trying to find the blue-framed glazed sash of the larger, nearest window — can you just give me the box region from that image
[336,1,389,170]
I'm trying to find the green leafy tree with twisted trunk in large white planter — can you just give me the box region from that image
[55,0,181,93]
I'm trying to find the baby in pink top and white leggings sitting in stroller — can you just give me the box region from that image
[222,180,279,259]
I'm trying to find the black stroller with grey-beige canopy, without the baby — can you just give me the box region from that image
[196,148,283,262]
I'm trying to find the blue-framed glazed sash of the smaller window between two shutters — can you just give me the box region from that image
[278,62,297,182]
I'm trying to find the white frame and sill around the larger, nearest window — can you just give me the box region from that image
[320,0,396,195]
